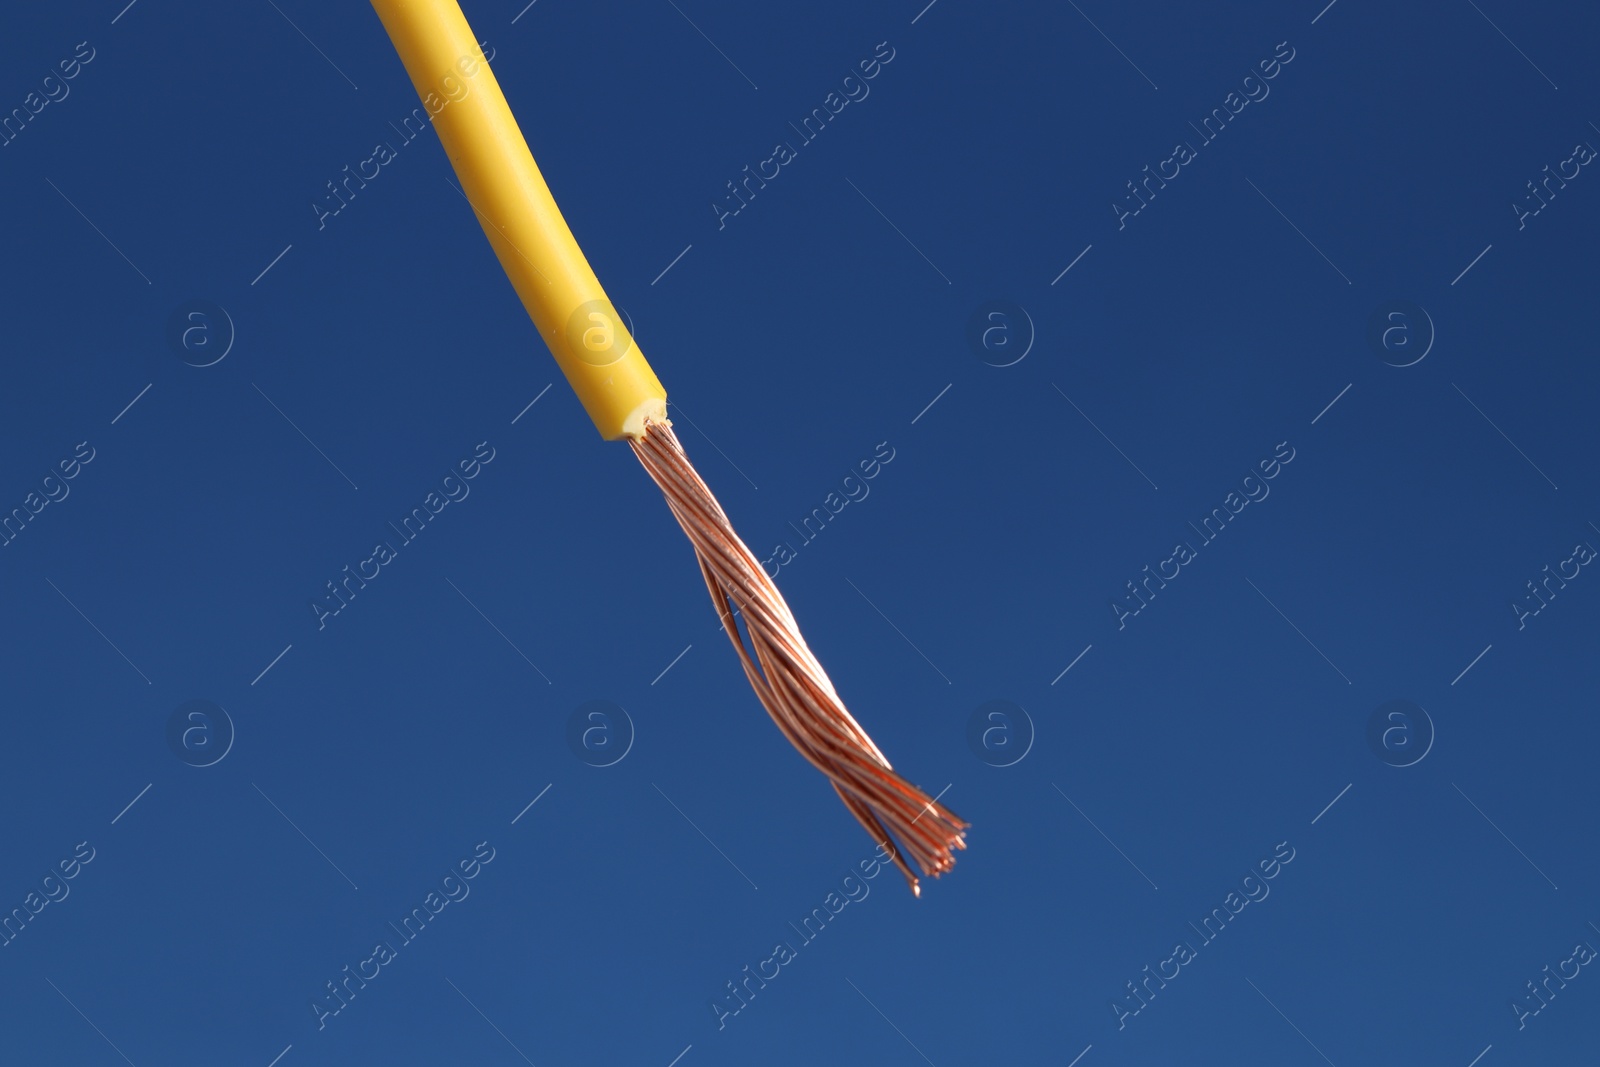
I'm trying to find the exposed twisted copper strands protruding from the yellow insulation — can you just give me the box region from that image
[629,421,968,896]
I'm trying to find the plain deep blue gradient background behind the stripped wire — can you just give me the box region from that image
[0,0,1600,1067]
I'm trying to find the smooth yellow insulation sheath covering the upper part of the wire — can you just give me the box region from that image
[371,0,667,440]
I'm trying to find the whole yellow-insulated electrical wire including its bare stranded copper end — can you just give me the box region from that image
[371,0,968,896]
